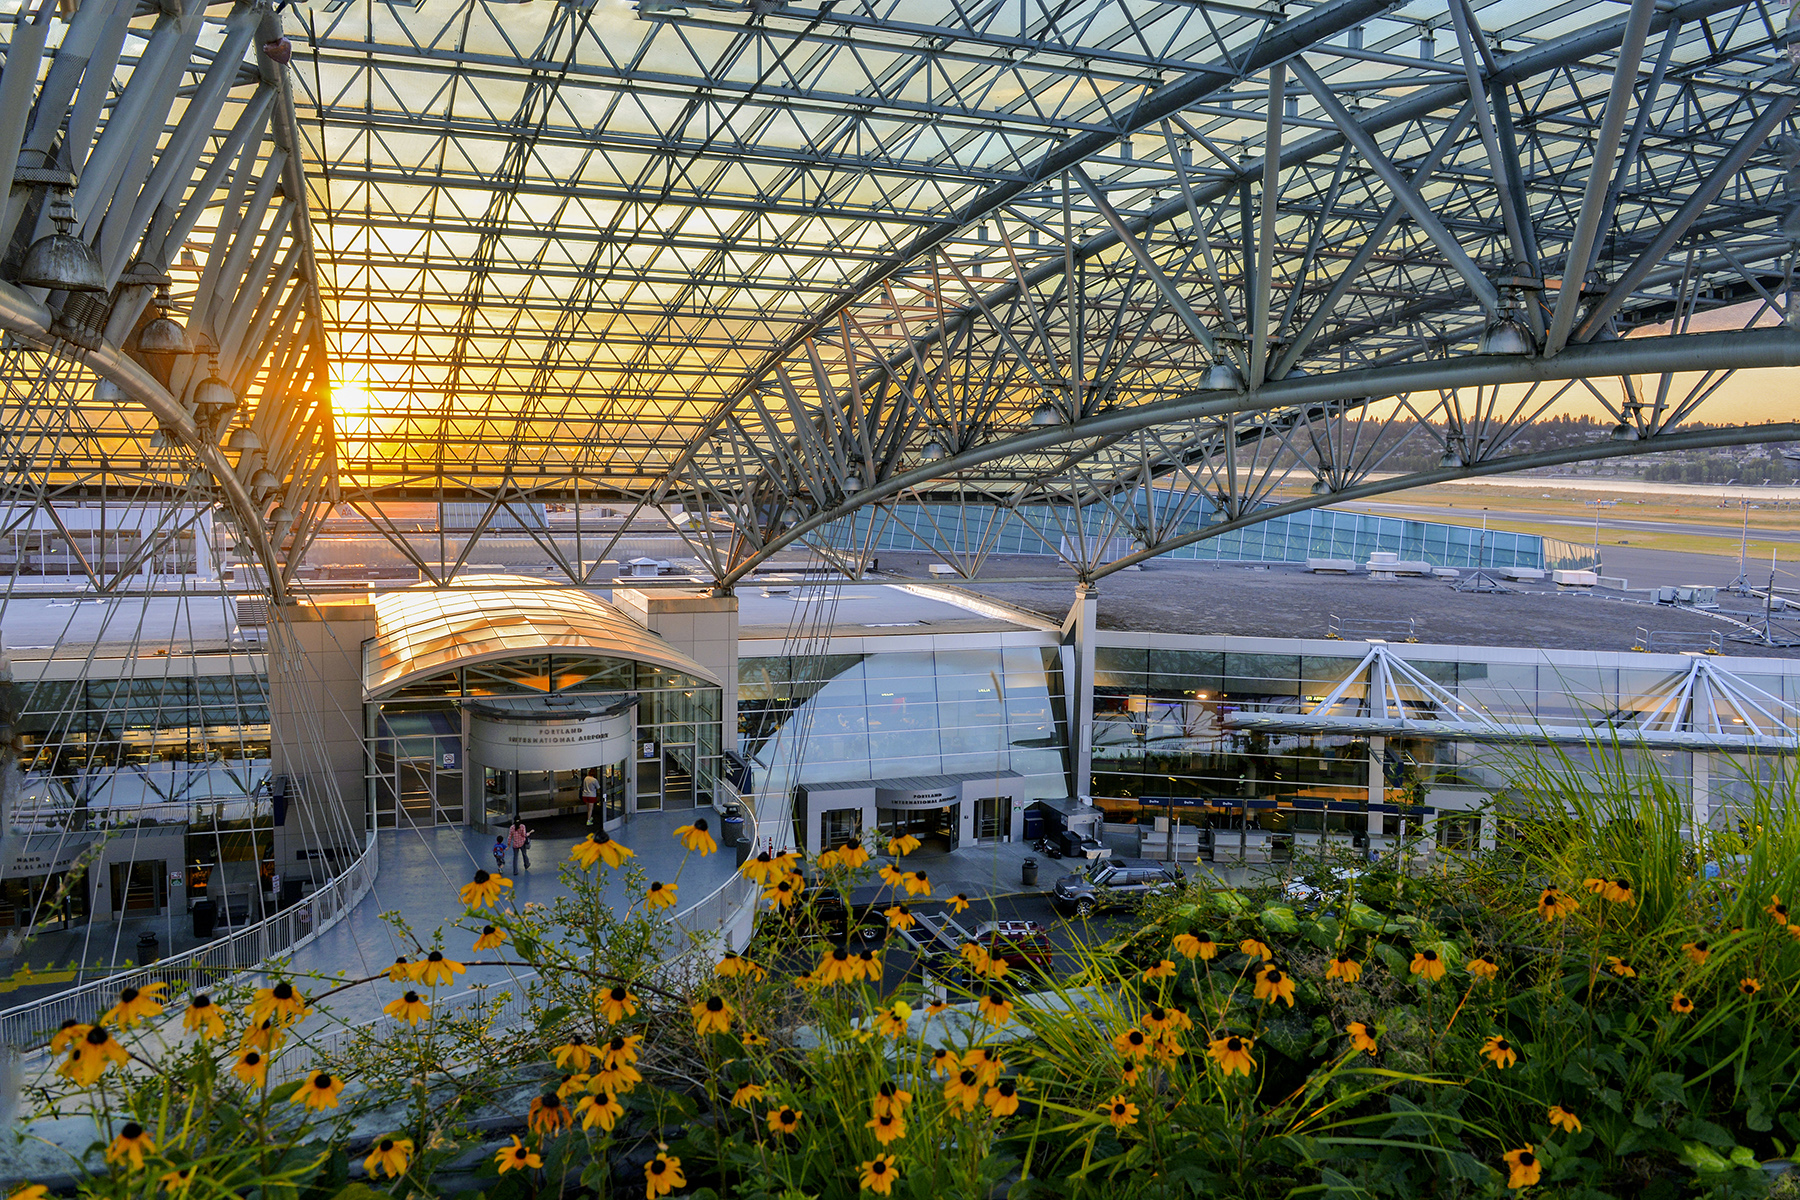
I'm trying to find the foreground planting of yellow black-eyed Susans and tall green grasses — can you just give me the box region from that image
[9,748,1800,1200]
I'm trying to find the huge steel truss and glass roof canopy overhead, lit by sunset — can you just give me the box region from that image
[0,0,1800,587]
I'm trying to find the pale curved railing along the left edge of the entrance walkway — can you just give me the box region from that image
[0,835,376,1054]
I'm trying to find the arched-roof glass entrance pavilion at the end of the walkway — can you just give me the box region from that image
[364,578,722,826]
